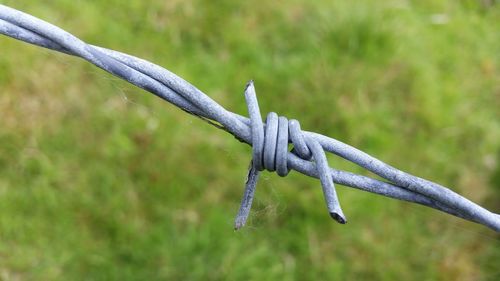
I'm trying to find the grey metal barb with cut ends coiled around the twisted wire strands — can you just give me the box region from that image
[234,81,347,229]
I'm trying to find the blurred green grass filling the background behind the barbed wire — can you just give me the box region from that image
[0,0,500,280]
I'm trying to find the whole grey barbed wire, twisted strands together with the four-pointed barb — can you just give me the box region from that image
[0,5,500,232]
